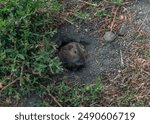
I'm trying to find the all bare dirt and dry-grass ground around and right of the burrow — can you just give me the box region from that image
[0,0,150,106]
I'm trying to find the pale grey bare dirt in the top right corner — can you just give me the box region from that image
[127,0,150,35]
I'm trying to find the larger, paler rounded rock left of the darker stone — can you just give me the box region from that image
[104,31,117,42]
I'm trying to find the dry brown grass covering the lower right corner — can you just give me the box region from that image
[99,42,150,106]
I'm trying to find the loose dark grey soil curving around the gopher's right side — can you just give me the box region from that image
[55,24,121,83]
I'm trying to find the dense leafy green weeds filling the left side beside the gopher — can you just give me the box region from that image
[0,0,62,102]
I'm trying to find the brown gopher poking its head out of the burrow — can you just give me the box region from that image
[58,42,87,70]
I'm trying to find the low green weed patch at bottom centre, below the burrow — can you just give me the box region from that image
[43,79,103,106]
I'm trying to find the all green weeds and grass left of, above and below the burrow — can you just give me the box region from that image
[0,0,137,106]
